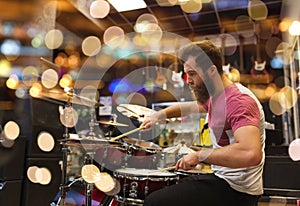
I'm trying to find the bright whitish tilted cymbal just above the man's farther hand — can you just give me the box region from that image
[117,104,156,122]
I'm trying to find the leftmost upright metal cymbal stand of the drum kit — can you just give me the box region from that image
[56,101,71,206]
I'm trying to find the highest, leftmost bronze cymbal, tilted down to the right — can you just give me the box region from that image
[38,90,103,106]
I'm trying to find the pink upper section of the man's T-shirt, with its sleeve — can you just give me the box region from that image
[205,84,260,146]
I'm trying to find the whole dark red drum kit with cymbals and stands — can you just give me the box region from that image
[36,87,210,206]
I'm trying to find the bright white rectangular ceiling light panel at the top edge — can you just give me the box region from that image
[108,0,147,12]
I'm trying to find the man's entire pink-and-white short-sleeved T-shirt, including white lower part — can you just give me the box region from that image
[204,84,265,195]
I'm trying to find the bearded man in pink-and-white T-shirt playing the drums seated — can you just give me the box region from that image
[141,40,265,206]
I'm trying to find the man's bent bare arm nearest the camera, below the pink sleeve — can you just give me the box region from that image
[176,126,262,169]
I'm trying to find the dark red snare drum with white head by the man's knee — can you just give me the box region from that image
[114,168,179,205]
